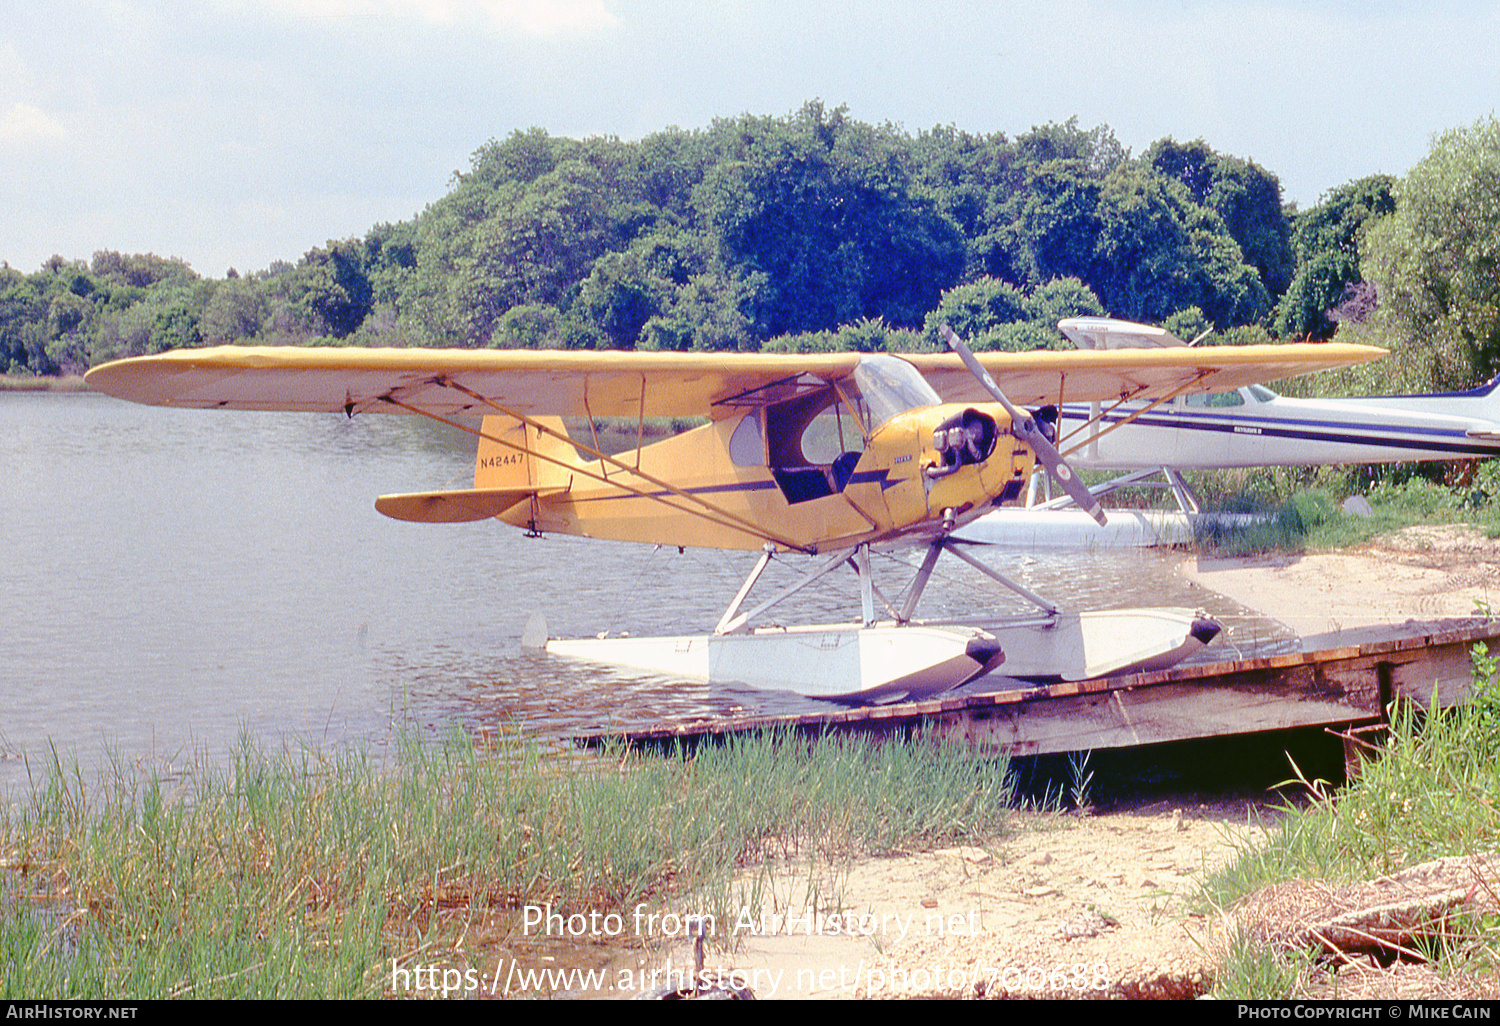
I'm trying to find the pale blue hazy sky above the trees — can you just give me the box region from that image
[0,0,1500,278]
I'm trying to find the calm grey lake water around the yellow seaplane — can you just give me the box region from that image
[0,392,1275,789]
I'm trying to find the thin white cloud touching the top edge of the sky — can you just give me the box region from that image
[252,0,618,36]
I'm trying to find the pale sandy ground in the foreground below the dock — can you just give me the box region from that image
[639,803,1262,999]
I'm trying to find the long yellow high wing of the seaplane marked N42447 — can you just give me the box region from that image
[87,344,1385,417]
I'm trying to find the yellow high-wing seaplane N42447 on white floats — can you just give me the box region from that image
[87,333,1382,702]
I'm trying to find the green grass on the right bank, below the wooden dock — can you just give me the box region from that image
[1203,645,1500,998]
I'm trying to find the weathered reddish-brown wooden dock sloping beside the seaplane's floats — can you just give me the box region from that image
[575,618,1500,755]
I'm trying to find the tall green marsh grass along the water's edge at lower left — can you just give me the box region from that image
[0,735,1010,999]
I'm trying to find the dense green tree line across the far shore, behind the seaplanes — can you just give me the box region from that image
[0,102,1500,384]
